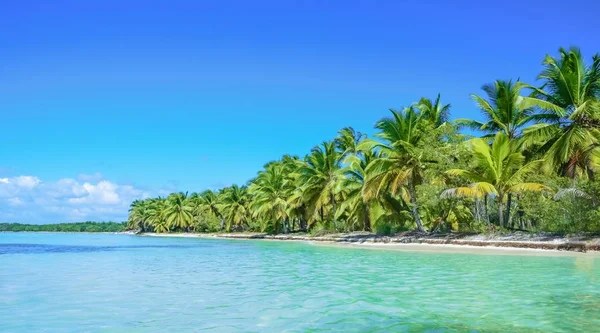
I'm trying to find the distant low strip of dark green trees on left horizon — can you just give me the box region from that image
[0,221,127,232]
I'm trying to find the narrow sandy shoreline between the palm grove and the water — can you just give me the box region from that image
[138,233,600,256]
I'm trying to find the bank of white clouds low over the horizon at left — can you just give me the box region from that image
[0,174,151,223]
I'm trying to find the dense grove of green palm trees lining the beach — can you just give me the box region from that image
[127,47,600,234]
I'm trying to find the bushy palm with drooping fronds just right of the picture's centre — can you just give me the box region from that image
[296,141,344,228]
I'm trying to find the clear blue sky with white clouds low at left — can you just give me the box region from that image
[0,0,600,223]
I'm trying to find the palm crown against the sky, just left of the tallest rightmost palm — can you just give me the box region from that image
[456,80,557,139]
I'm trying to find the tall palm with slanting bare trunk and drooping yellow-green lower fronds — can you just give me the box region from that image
[361,107,430,232]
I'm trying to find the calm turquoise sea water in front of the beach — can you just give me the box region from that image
[0,233,600,332]
